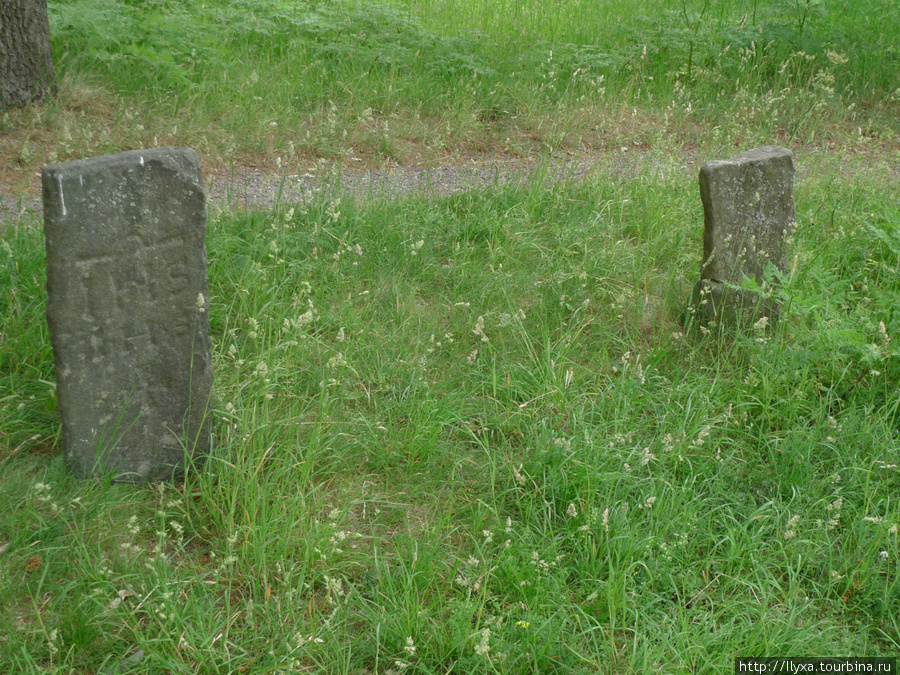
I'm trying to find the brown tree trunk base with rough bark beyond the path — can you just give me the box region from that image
[0,0,53,110]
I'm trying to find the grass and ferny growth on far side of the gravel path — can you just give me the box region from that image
[2,0,900,165]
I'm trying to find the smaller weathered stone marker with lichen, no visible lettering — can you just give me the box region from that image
[695,146,794,323]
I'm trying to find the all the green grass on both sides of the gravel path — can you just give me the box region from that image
[0,0,900,675]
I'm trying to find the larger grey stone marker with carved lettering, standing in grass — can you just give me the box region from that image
[42,148,212,482]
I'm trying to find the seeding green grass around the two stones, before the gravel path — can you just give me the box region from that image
[0,156,900,673]
